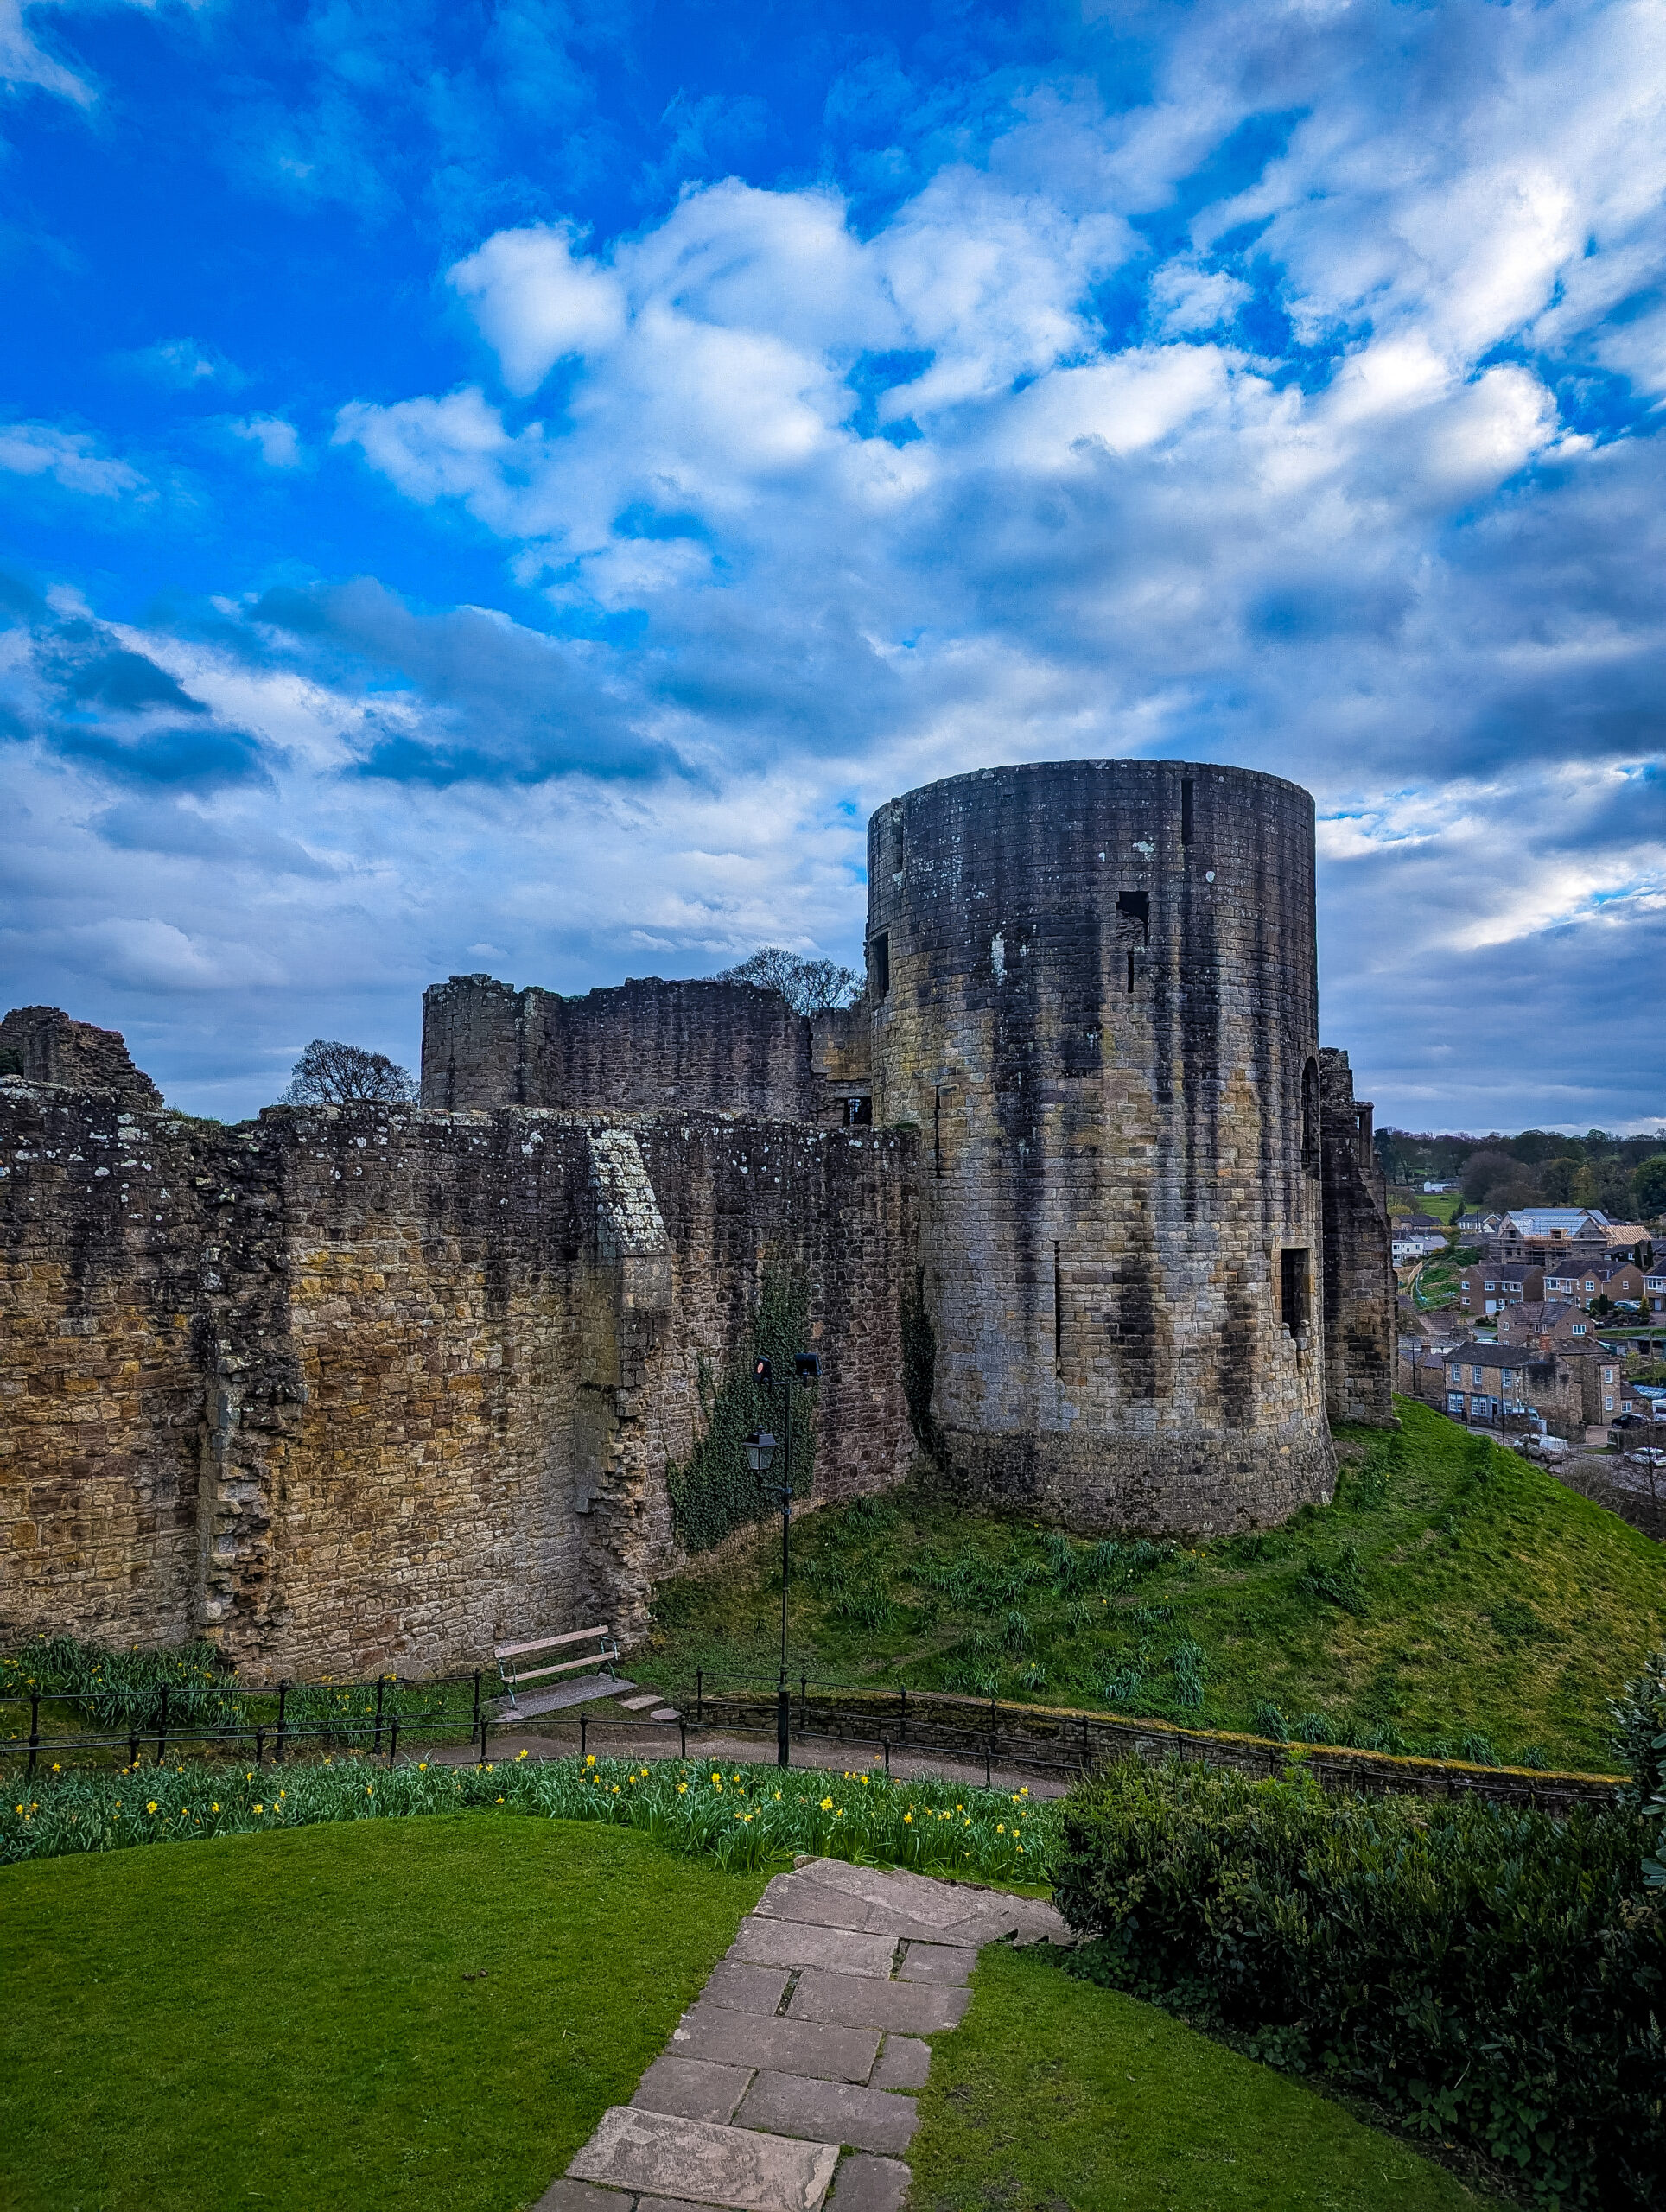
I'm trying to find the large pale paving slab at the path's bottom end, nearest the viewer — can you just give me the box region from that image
[569,2104,838,2212]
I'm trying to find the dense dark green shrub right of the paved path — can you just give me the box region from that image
[1055,1761,1666,2208]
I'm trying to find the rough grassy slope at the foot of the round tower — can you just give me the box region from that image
[639,1400,1666,1772]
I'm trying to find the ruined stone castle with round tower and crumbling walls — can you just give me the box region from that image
[0,761,1394,1675]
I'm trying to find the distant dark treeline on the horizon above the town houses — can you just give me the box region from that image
[1377,1128,1666,1221]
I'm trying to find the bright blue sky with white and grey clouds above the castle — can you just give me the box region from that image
[0,0,1666,1130]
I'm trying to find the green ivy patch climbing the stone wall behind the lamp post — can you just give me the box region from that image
[666,1268,818,1551]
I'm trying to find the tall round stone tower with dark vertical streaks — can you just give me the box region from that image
[868,761,1334,1531]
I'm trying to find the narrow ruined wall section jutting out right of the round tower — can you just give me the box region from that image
[1319,1048,1398,1427]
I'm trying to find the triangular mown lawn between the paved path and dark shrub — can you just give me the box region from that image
[909,1948,1496,2212]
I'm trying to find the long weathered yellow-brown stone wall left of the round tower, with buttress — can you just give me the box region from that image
[0,1084,913,1672]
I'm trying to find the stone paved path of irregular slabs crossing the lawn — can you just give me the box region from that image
[536,1858,1071,2212]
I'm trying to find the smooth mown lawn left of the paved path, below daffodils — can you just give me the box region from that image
[0,1812,763,2212]
